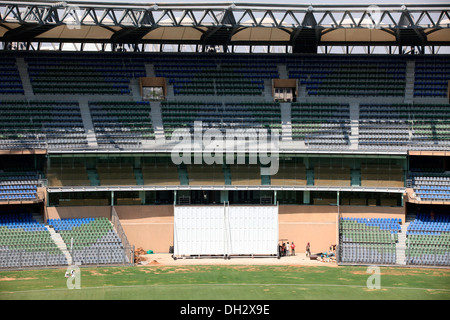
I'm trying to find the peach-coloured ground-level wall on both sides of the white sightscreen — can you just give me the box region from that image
[47,205,405,254]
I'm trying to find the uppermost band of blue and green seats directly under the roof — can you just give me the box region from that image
[4,52,450,97]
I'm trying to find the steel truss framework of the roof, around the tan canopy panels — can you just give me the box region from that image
[0,0,450,47]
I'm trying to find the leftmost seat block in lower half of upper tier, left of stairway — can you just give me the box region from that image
[0,101,87,149]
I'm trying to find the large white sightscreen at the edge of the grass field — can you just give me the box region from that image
[174,206,278,256]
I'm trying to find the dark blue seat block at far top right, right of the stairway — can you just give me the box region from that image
[414,56,450,97]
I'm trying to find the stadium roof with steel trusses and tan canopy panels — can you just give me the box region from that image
[0,1,450,53]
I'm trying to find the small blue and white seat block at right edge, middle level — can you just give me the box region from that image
[410,171,450,201]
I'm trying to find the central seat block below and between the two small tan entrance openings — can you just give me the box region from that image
[161,101,281,138]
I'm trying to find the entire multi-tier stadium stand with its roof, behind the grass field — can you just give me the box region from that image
[0,0,450,268]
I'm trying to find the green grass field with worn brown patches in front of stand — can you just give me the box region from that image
[0,265,450,300]
